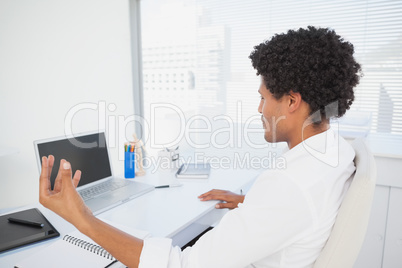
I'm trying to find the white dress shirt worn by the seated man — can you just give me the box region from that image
[139,129,355,268]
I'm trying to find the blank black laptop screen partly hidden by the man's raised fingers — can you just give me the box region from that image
[37,132,112,189]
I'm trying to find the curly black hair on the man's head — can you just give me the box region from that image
[249,26,361,120]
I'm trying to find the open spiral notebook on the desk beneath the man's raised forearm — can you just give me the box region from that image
[14,221,149,268]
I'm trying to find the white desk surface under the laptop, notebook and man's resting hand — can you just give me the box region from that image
[0,169,260,267]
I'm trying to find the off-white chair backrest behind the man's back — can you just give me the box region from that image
[314,138,377,268]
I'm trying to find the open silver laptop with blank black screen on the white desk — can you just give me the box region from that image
[34,132,154,215]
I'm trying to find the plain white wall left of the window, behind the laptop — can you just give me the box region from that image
[0,0,134,209]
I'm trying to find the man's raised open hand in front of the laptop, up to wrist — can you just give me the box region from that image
[39,155,92,229]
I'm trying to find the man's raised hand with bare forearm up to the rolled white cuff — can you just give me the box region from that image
[39,155,143,267]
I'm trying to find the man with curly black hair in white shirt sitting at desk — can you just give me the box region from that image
[40,27,360,268]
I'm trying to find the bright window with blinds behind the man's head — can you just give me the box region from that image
[141,0,402,159]
